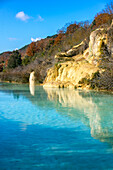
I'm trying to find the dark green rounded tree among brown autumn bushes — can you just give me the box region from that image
[8,50,22,68]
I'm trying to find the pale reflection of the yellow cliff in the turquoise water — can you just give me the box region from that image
[45,88,113,145]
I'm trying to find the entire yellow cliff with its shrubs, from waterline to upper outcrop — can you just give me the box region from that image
[44,24,113,89]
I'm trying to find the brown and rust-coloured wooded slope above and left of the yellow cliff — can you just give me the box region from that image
[0,2,113,87]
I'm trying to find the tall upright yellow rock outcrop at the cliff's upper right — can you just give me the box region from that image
[88,24,113,65]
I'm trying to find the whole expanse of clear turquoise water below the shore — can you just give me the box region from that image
[0,83,113,170]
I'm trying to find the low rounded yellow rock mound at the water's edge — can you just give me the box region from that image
[44,62,99,88]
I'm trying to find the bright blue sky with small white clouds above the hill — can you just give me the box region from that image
[0,0,109,53]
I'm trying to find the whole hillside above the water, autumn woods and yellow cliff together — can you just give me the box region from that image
[0,3,113,89]
